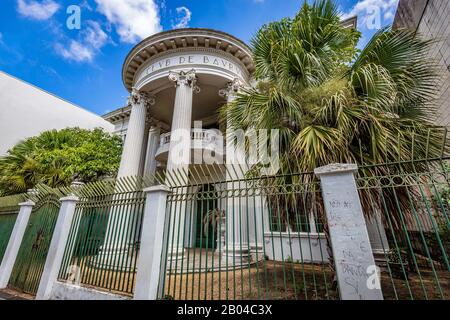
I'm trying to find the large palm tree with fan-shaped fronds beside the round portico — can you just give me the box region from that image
[221,0,445,284]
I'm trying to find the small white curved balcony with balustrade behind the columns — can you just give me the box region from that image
[155,129,224,164]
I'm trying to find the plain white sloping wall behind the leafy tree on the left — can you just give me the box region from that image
[0,71,114,155]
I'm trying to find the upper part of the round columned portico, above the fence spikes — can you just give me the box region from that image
[105,29,254,177]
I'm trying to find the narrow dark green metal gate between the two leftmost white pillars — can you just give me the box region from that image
[9,194,60,294]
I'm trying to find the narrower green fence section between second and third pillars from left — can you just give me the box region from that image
[59,178,144,294]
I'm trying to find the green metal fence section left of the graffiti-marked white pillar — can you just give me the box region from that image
[156,169,338,300]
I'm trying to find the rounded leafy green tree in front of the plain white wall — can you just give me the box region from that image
[0,128,122,195]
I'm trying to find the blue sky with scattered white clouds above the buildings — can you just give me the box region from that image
[0,0,398,115]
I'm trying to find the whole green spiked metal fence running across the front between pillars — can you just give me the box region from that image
[0,158,450,300]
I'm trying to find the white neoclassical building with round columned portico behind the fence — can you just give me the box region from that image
[104,26,356,264]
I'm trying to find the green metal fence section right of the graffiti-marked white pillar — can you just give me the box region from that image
[357,159,450,300]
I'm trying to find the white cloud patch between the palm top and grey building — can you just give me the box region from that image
[342,0,399,23]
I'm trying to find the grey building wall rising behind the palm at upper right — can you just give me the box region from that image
[394,0,450,126]
